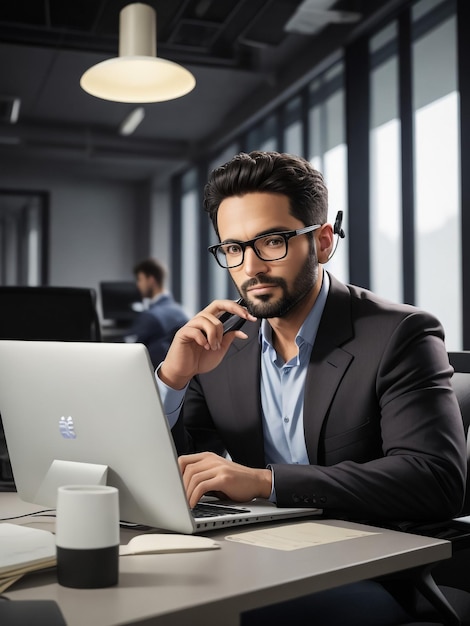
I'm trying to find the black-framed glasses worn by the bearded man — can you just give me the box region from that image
[208,224,322,269]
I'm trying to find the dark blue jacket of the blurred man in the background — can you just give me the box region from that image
[127,293,188,367]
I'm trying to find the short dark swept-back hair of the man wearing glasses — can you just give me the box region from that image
[204,151,328,234]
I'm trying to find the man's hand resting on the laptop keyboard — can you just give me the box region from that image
[178,452,271,508]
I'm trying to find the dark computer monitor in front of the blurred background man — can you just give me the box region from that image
[100,280,142,326]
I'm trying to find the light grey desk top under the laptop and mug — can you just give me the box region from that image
[0,493,452,626]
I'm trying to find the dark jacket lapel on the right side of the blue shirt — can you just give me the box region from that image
[304,275,353,464]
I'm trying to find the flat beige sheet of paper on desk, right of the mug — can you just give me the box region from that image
[225,522,377,550]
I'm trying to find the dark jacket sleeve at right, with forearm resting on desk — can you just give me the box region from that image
[274,304,466,521]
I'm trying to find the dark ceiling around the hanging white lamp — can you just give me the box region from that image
[0,0,398,188]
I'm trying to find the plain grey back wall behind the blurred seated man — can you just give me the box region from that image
[0,162,170,314]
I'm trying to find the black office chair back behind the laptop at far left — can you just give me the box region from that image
[0,287,101,491]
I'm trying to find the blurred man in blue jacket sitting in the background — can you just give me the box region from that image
[125,259,188,367]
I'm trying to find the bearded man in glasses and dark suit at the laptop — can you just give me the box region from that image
[157,152,466,624]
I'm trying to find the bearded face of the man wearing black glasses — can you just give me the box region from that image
[217,192,318,318]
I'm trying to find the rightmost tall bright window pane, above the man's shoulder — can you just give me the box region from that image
[412,0,462,350]
